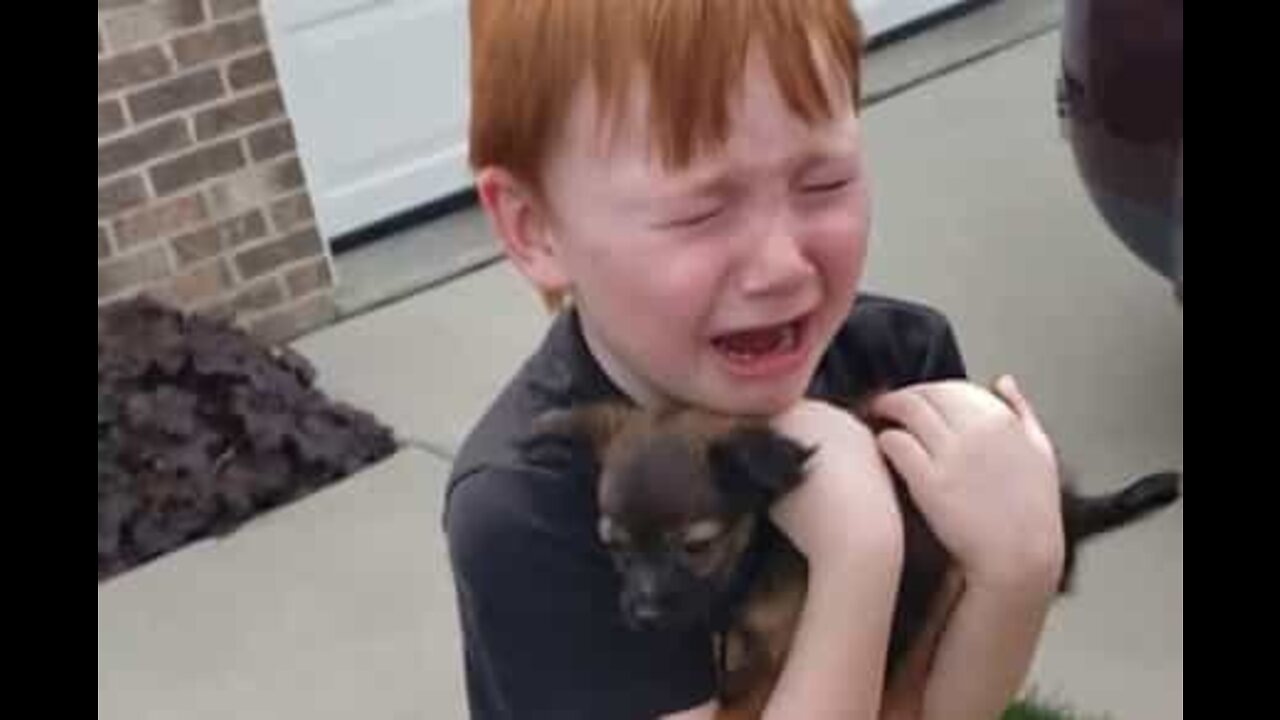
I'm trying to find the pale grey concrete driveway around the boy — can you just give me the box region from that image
[99,22,1184,720]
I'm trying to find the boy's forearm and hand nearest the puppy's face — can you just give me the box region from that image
[675,402,902,720]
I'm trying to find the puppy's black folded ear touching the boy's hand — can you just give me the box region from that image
[707,425,817,509]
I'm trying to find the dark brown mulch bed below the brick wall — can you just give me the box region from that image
[97,299,397,583]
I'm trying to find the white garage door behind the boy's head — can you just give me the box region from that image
[264,0,959,240]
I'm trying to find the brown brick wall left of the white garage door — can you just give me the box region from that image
[97,0,335,341]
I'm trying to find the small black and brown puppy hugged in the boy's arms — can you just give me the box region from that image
[524,404,1180,717]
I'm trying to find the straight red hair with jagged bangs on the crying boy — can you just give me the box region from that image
[470,0,863,190]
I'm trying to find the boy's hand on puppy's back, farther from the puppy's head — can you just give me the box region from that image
[870,378,1065,594]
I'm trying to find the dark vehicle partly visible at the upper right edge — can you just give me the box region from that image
[1057,0,1183,302]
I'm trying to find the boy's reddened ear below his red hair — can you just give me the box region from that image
[476,168,568,296]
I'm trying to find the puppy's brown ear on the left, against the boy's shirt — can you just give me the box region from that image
[517,404,631,471]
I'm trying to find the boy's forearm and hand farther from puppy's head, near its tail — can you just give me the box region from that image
[878,379,1064,720]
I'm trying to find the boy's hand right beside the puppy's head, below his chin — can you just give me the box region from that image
[771,400,902,571]
